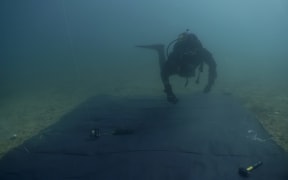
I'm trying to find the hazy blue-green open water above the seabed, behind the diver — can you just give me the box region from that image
[0,0,288,98]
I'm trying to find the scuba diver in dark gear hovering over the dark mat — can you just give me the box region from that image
[136,29,217,104]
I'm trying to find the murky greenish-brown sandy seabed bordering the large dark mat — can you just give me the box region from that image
[0,83,288,158]
